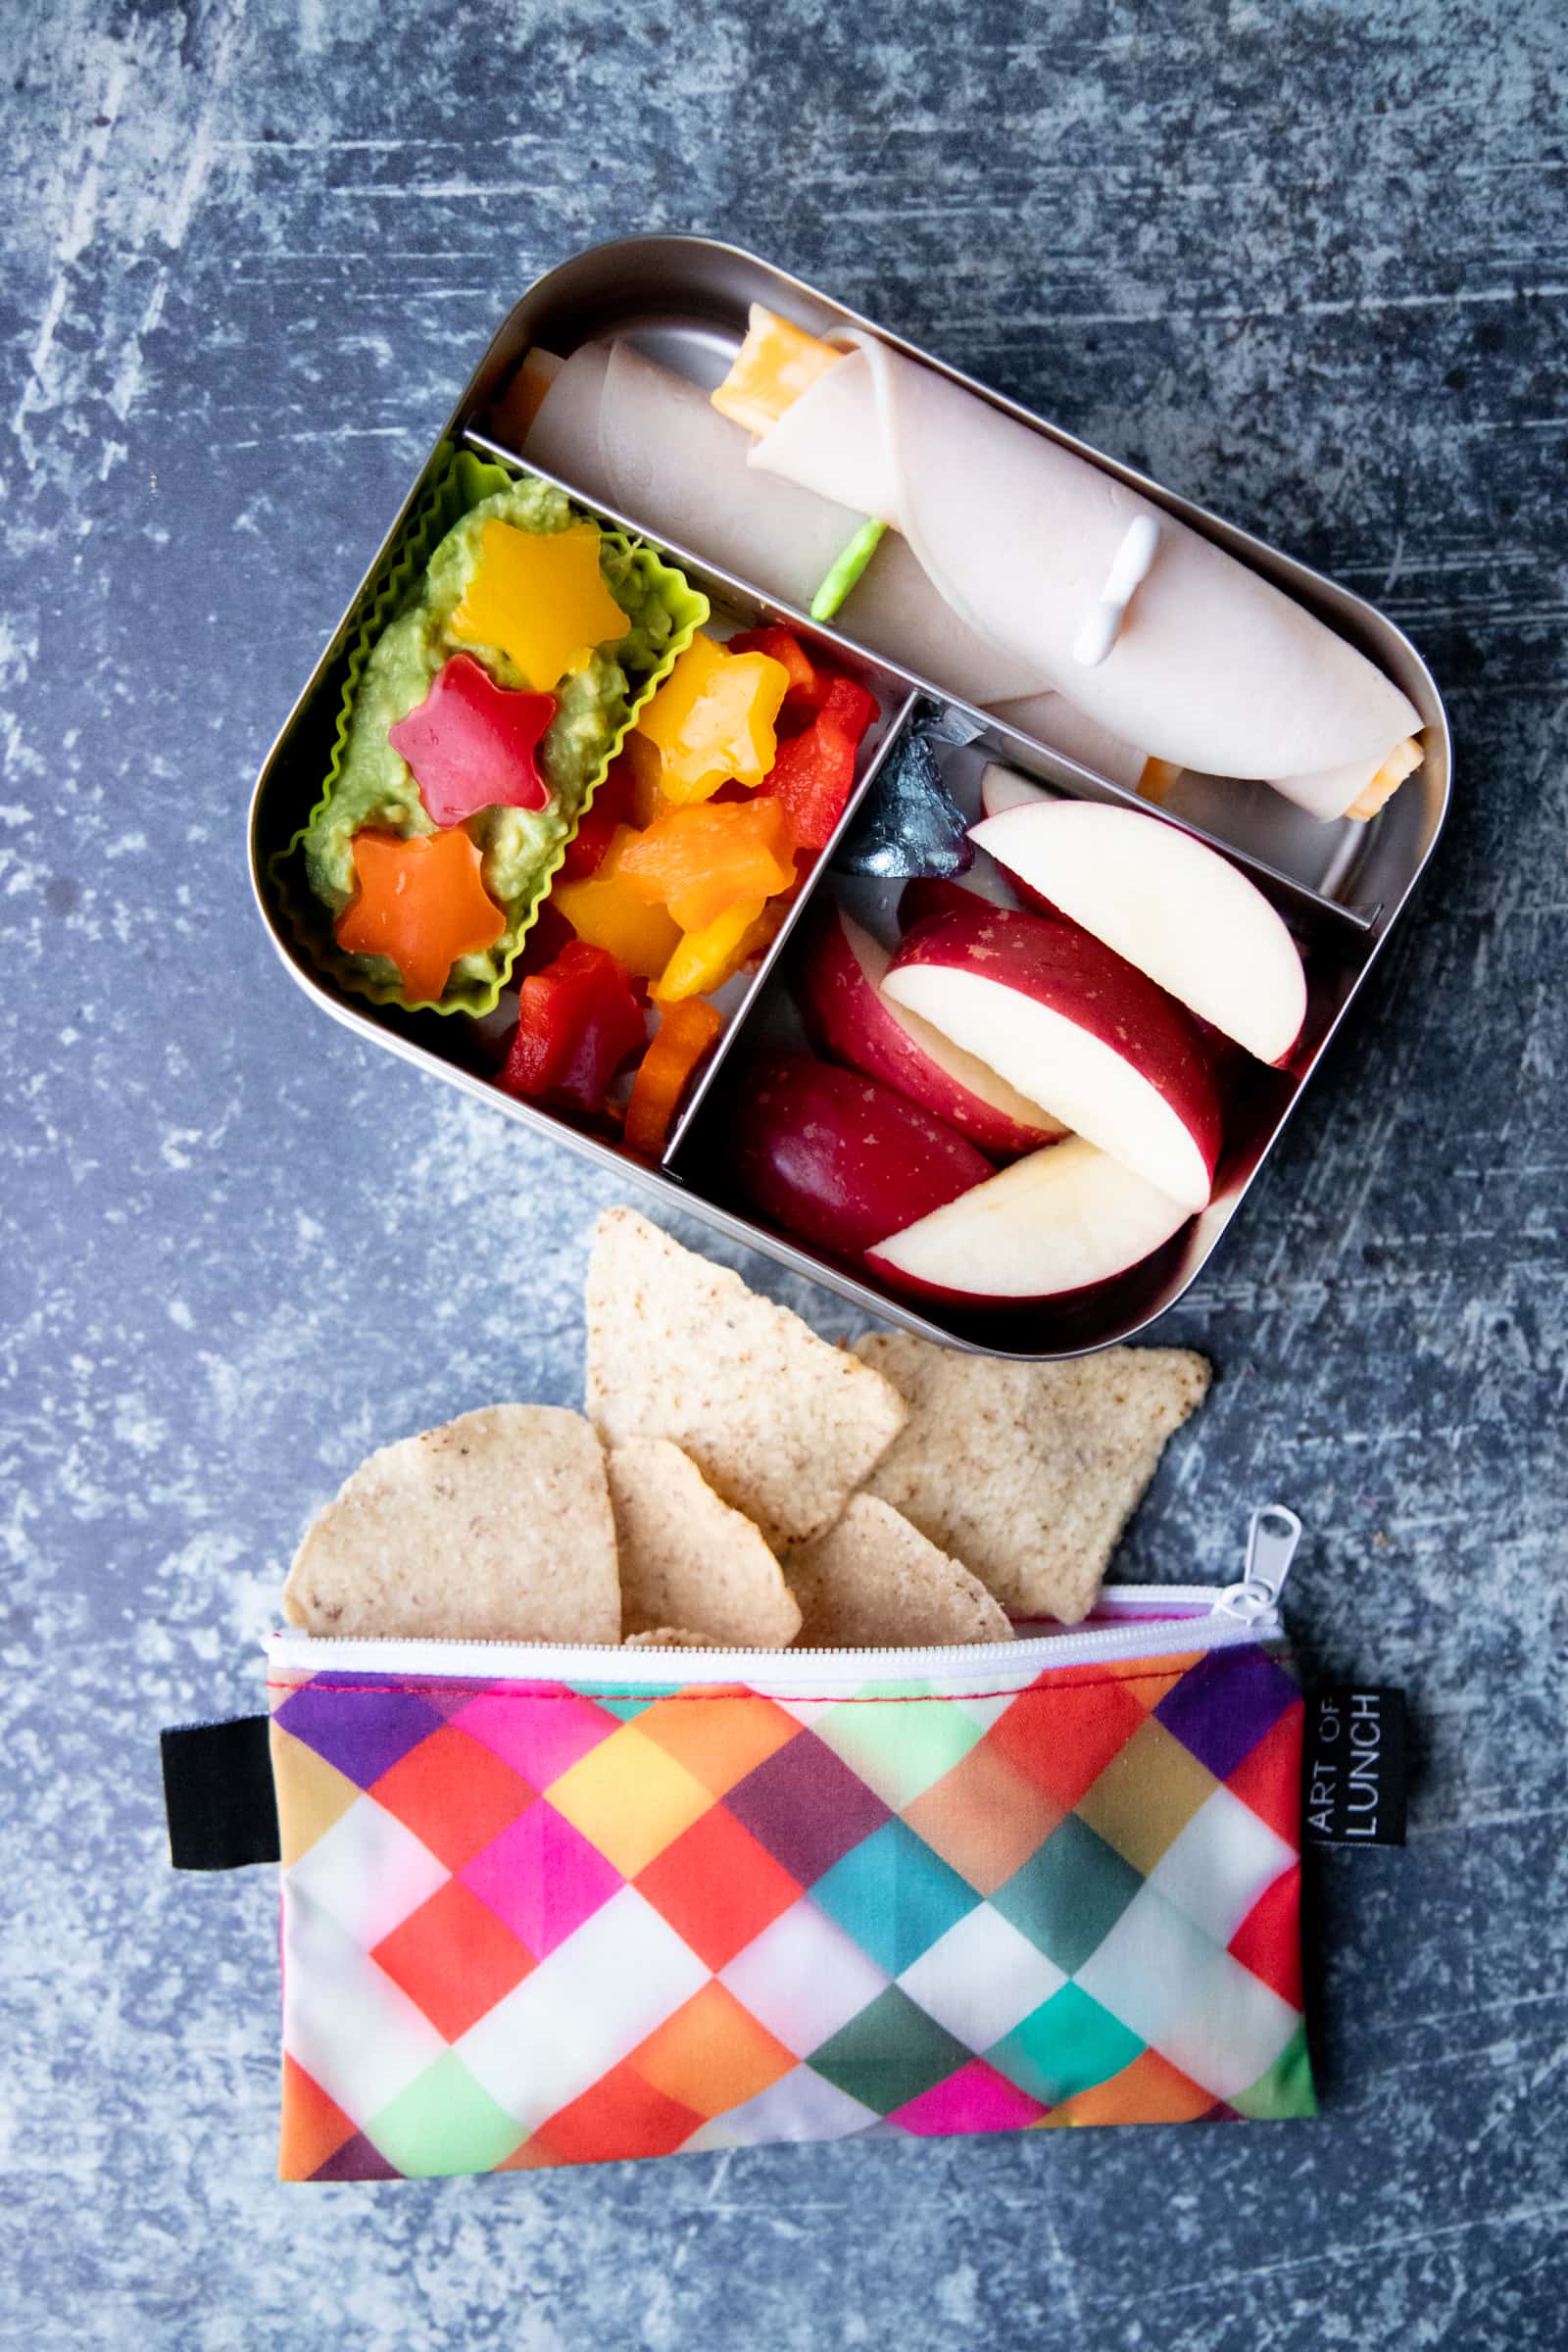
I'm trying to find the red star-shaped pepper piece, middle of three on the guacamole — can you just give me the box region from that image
[385,654,558,830]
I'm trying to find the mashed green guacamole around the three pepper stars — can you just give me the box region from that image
[301,480,677,993]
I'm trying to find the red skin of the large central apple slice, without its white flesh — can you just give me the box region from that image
[889,906,1222,1181]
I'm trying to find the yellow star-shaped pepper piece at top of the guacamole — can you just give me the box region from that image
[449,522,632,694]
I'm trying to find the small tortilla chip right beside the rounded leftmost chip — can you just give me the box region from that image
[609,1437,800,1648]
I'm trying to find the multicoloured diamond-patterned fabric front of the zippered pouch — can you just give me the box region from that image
[272,1644,1312,2180]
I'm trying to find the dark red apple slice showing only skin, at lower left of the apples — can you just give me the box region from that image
[731,1054,995,1258]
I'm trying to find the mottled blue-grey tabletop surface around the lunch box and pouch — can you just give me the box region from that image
[0,0,1568,2352]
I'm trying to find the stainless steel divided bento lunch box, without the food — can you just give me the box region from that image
[249,237,1450,1359]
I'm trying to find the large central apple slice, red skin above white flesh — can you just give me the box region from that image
[882,906,1220,1209]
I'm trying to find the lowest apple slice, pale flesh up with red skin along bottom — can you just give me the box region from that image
[865,1136,1192,1307]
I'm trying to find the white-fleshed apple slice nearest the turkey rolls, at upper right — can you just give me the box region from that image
[971,800,1307,1063]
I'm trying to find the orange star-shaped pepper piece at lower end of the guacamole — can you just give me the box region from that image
[336,825,506,1004]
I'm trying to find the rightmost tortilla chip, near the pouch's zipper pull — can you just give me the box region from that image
[856,1331,1208,1625]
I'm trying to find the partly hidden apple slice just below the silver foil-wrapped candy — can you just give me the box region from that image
[790,887,1062,1159]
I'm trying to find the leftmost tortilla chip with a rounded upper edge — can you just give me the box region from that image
[282,1404,620,1642]
